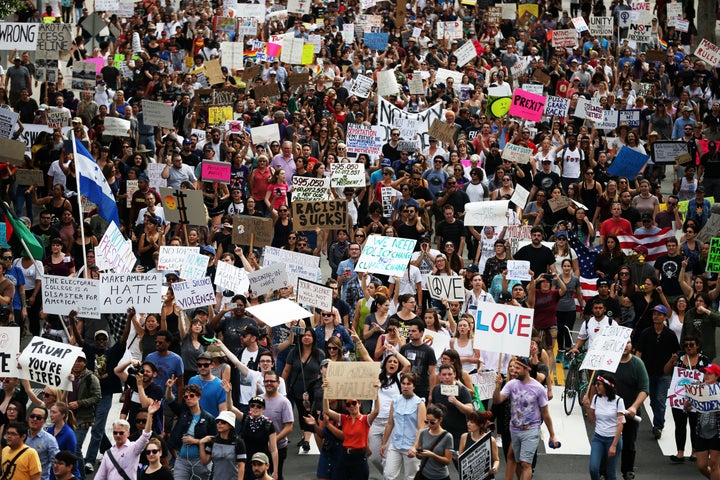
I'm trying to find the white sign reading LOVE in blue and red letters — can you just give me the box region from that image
[473,304,534,355]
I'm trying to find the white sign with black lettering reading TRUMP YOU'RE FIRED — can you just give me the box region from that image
[17,337,83,391]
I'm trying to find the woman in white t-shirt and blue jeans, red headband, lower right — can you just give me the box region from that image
[585,373,625,480]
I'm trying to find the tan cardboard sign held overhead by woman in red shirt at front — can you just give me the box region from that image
[325,362,380,400]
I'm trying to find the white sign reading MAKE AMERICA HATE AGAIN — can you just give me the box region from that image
[99,272,163,313]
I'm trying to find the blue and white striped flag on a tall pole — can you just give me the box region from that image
[73,137,120,225]
